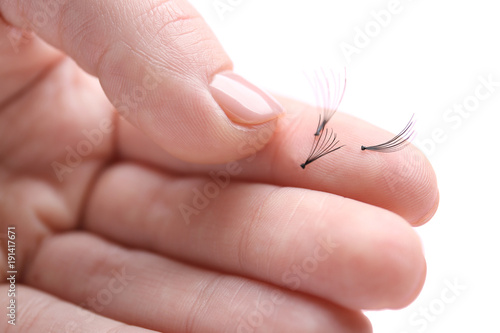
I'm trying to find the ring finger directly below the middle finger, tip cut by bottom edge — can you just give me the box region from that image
[26,233,371,333]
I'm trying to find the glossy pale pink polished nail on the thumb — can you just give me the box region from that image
[210,72,285,125]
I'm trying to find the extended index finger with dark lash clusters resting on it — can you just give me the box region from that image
[119,98,439,225]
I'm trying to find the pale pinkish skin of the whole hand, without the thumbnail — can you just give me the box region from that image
[0,0,439,332]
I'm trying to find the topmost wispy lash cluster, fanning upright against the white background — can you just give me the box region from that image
[309,67,347,136]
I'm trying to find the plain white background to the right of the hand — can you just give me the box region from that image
[191,0,500,333]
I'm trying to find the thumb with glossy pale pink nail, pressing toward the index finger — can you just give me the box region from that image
[0,0,284,163]
